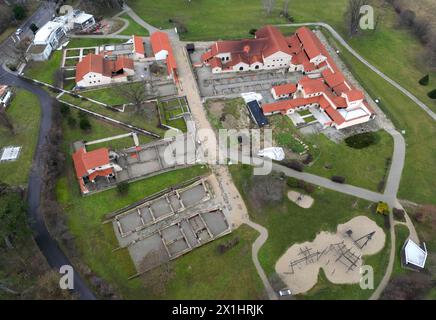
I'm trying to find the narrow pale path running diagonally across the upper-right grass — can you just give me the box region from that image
[277,22,436,120]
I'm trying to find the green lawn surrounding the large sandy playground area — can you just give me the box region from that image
[230,165,390,299]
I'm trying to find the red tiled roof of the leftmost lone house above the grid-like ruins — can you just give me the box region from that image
[73,148,109,178]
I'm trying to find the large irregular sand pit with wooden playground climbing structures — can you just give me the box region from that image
[275,216,386,294]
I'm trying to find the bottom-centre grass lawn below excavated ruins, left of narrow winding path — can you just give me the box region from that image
[165,225,265,300]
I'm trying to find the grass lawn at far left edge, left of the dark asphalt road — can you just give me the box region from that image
[0,90,41,185]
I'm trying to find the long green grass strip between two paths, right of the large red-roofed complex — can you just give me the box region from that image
[324,32,436,204]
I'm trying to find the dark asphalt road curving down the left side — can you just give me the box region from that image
[0,66,96,300]
